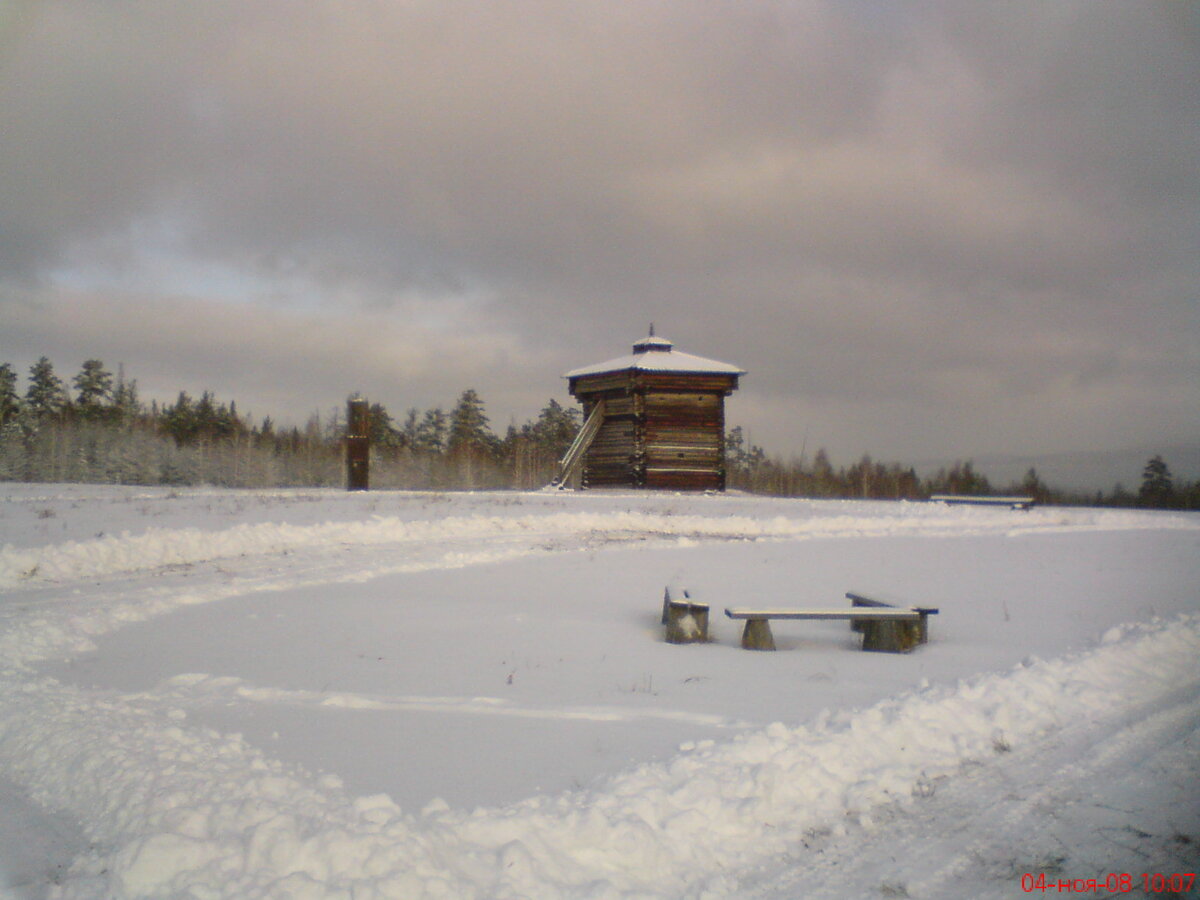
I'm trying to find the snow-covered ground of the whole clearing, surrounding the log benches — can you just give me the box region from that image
[0,485,1200,900]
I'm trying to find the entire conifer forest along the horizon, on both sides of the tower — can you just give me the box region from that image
[0,356,1200,510]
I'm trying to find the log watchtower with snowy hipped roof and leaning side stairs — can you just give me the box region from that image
[554,325,745,491]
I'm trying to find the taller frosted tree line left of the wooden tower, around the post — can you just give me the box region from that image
[0,356,581,490]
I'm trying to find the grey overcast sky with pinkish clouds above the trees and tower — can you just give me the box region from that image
[0,0,1200,480]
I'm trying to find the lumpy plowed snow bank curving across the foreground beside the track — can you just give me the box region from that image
[0,617,1200,898]
